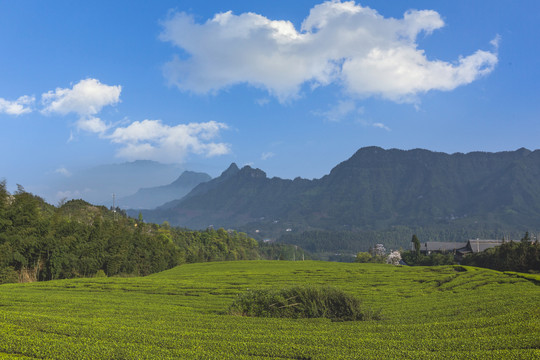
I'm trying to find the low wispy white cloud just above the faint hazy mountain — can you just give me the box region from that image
[107,120,230,163]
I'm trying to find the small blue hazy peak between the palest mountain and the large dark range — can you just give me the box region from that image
[118,171,212,209]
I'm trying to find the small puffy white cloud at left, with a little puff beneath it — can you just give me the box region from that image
[41,79,122,134]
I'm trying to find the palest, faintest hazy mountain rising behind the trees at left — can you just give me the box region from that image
[55,160,182,206]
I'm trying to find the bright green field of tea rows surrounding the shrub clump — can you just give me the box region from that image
[0,261,540,359]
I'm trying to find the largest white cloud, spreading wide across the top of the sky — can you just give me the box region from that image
[160,0,498,102]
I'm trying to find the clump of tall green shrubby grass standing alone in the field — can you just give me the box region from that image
[229,286,379,321]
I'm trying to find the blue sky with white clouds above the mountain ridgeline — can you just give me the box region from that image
[0,0,540,201]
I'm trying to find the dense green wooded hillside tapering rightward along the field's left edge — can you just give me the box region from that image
[0,181,289,283]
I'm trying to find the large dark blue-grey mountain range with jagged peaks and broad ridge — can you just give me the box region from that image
[138,147,540,236]
